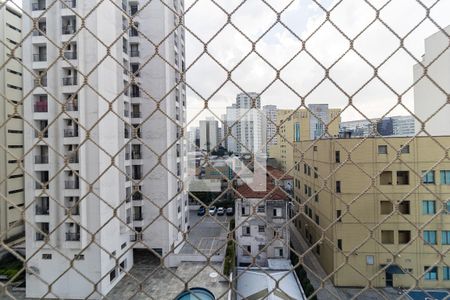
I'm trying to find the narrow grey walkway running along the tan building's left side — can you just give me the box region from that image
[290,223,347,300]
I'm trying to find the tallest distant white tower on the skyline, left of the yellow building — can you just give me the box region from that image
[236,93,266,154]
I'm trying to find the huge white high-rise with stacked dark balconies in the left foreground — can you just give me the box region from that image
[23,0,187,299]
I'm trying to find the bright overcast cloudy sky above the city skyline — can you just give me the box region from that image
[186,0,450,124]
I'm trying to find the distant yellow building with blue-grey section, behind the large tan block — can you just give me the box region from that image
[269,104,341,172]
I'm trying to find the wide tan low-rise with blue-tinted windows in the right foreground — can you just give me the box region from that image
[294,137,450,289]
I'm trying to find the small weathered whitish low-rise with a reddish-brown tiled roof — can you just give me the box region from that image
[235,179,290,267]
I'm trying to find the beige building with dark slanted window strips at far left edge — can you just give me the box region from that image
[0,1,25,241]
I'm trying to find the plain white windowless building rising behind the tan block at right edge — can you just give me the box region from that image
[414,26,450,135]
